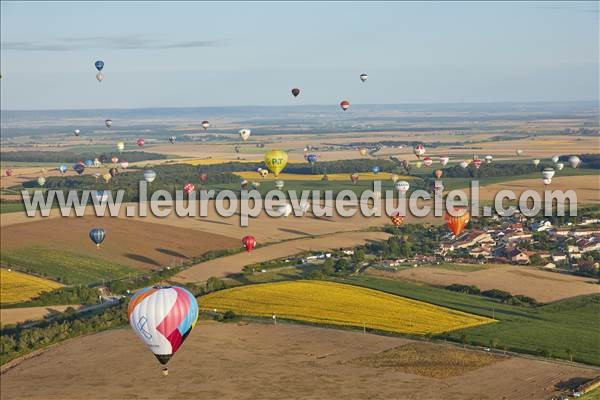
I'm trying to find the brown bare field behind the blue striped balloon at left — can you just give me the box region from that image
[1,216,240,270]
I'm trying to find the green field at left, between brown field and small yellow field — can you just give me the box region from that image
[0,246,137,285]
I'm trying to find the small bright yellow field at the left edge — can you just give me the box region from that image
[0,268,62,304]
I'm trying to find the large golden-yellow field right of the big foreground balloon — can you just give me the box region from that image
[200,281,495,335]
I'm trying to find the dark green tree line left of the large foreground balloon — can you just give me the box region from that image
[0,302,127,364]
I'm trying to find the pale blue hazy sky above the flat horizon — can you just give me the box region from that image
[0,1,599,109]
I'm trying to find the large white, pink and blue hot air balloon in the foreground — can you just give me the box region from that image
[127,286,198,375]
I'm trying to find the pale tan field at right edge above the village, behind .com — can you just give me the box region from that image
[479,172,600,204]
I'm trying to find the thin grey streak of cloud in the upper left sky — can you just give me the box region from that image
[2,35,227,51]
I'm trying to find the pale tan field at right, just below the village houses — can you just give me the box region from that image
[369,265,600,303]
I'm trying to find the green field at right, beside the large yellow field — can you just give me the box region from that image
[338,276,600,365]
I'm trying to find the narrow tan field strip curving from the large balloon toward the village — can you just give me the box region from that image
[173,232,389,283]
